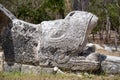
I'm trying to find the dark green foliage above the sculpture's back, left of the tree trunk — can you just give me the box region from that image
[0,0,65,23]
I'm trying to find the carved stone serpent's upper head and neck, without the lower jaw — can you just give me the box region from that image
[0,5,98,69]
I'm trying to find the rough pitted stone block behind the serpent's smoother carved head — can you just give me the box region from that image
[11,19,40,64]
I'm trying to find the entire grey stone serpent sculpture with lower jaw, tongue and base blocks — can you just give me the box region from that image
[0,5,120,73]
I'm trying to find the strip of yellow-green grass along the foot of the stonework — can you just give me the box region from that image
[0,72,120,80]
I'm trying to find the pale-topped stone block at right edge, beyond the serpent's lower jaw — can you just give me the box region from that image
[101,56,120,74]
